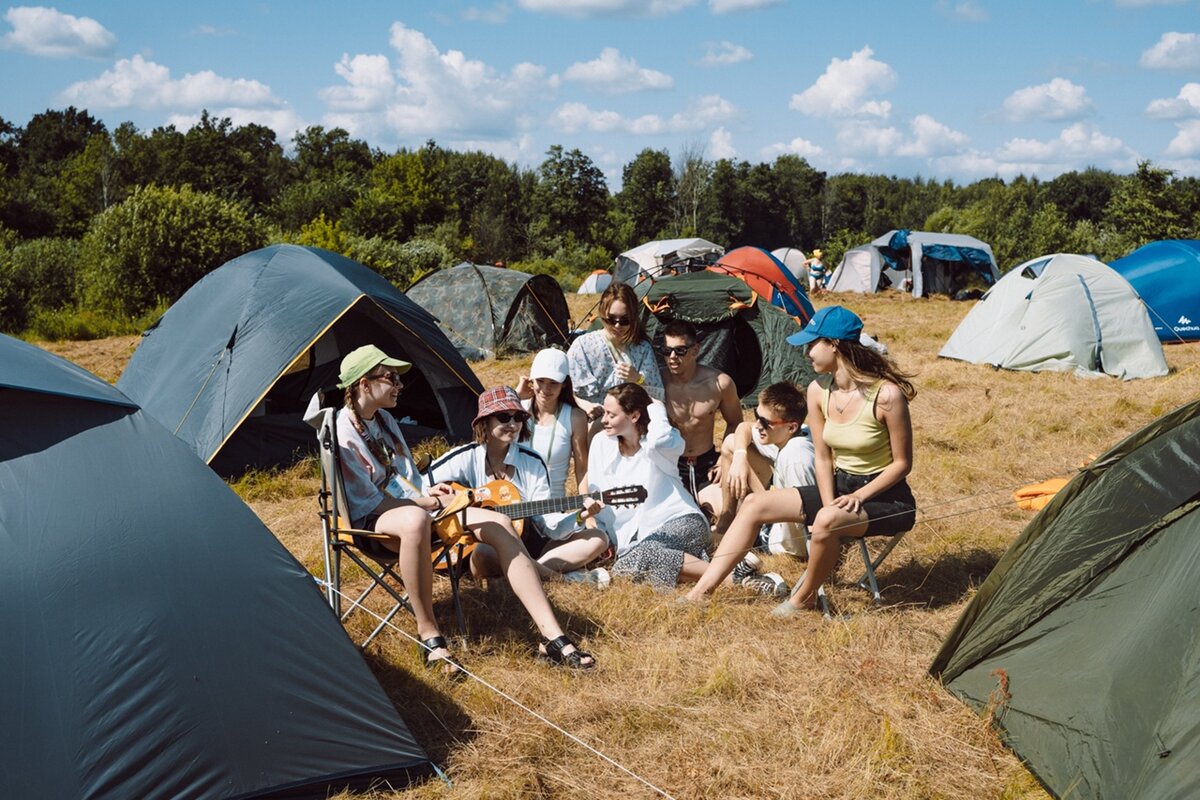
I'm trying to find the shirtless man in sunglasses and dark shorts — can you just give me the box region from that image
[661,320,742,495]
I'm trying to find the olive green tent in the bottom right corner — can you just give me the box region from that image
[930,401,1200,798]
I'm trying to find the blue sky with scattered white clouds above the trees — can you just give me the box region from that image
[7,0,1200,190]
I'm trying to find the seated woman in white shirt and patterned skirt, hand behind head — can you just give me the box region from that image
[588,383,710,589]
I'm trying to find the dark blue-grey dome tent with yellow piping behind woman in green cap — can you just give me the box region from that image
[116,245,482,475]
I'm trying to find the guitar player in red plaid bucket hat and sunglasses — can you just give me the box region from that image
[428,386,608,587]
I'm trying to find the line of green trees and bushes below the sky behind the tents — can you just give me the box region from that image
[0,107,1200,337]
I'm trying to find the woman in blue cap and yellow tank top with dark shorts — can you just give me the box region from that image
[772,306,917,616]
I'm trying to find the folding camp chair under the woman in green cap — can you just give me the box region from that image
[306,408,475,648]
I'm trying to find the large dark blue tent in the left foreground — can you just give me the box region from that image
[0,337,430,799]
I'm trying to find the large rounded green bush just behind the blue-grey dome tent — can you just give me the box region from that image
[83,186,265,315]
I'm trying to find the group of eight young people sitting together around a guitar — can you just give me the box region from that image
[337,283,916,674]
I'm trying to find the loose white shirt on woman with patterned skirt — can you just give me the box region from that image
[588,403,700,555]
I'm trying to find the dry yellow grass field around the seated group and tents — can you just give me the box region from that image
[48,294,1200,800]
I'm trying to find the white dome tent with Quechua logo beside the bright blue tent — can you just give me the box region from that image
[938,253,1168,380]
